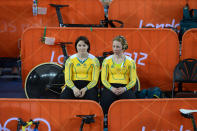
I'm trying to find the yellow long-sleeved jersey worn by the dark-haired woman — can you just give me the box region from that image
[65,54,100,89]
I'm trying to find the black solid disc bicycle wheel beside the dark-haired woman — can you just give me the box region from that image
[25,63,65,99]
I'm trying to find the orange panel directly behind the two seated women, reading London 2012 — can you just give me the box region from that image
[21,28,179,90]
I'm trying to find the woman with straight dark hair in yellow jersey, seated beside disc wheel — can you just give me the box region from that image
[60,36,100,101]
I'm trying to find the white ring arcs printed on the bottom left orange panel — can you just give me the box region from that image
[0,117,51,131]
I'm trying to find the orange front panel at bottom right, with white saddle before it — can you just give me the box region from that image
[108,98,197,131]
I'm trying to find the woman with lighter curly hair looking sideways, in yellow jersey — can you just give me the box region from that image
[101,36,137,114]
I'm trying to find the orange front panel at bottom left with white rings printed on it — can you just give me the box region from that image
[0,99,103,131]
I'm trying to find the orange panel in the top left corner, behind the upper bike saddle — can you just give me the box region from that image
[0,0,104,58]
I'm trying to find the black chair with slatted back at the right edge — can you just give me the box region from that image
[172,58,197,98]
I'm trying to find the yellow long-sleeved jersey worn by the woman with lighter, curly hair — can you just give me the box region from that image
[101,55,137,90]
